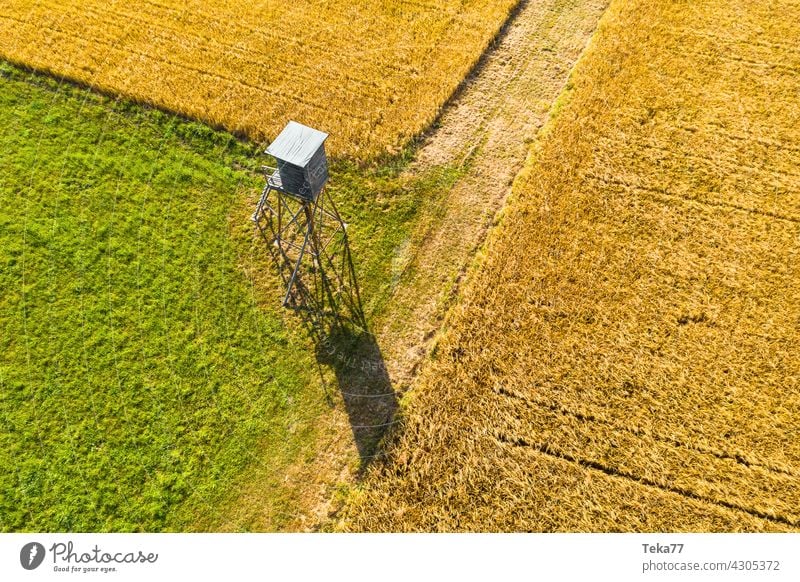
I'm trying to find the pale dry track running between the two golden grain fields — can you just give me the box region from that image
[378,0,608,393]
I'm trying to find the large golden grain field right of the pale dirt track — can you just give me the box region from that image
[343,0,800,531]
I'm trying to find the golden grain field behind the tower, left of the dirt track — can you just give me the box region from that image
[0,0,516,158]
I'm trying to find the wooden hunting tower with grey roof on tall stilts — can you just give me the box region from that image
[252,121,360,324]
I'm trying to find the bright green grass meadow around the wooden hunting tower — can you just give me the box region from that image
[0,64,456,531]
